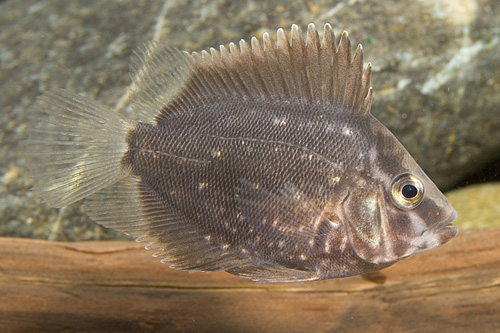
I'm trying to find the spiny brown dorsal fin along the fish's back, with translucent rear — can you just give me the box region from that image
[134,24,372,121]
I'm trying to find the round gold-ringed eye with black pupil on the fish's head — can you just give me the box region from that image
[391,173,424,210]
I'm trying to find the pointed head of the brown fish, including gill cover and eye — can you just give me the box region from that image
[337,121,458,265]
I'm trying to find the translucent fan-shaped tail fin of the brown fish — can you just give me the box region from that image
[26,90,133,207]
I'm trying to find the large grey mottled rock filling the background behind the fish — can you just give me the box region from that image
[0,0,500,240]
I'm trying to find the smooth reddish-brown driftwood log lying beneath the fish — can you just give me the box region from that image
[0,228,500,332]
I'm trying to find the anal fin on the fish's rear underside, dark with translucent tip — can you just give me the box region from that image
[85,177,241,272]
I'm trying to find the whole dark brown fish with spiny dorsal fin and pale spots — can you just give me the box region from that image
[26,24,458,282]
